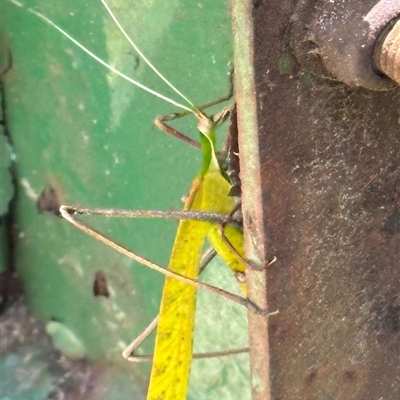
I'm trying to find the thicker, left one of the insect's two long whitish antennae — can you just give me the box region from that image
[28,8,193,113]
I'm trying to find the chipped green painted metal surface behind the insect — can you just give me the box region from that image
[2,0,250,399]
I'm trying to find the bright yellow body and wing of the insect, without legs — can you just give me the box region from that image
[147,142,246,400]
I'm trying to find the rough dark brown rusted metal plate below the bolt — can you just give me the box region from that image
[234,0,400,400]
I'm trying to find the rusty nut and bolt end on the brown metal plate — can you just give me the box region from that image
[290,0,400,90]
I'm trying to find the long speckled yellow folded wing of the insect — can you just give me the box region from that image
[147,179,209,400]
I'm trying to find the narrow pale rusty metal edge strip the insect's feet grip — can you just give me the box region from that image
[232,0,271,400]
